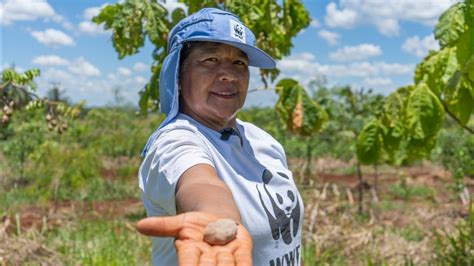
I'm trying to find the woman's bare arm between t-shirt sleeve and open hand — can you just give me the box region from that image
[176,164,241,223]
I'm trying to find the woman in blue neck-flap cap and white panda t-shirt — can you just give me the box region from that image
[137,8,303,265]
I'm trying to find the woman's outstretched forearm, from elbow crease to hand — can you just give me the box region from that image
[176,180,240,222]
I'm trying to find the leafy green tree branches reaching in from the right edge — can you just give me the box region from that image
[357,0,474,203]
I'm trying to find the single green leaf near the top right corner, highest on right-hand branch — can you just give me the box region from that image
[434,3,465,48]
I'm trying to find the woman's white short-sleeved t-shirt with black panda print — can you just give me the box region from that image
[139,114,304,265]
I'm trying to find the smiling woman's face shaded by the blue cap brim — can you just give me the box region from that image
[180,42,249,130]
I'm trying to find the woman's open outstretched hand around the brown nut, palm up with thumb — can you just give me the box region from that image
[137,212,252,266]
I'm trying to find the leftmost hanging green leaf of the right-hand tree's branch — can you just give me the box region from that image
[356,119,383,164]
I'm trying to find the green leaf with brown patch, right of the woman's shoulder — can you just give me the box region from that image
[275,79,327,136]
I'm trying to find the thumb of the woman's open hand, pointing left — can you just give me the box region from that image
[136,215,184,237]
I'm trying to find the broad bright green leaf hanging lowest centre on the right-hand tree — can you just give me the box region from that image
[406,82,444,139]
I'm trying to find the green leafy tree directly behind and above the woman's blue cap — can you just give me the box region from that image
[92,0,310,113]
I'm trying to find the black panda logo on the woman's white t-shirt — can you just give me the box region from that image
[257,169,301,245]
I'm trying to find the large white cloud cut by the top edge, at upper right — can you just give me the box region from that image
[325,0,459,36]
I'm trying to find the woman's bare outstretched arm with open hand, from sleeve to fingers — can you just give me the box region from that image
[137,164,252,266]
